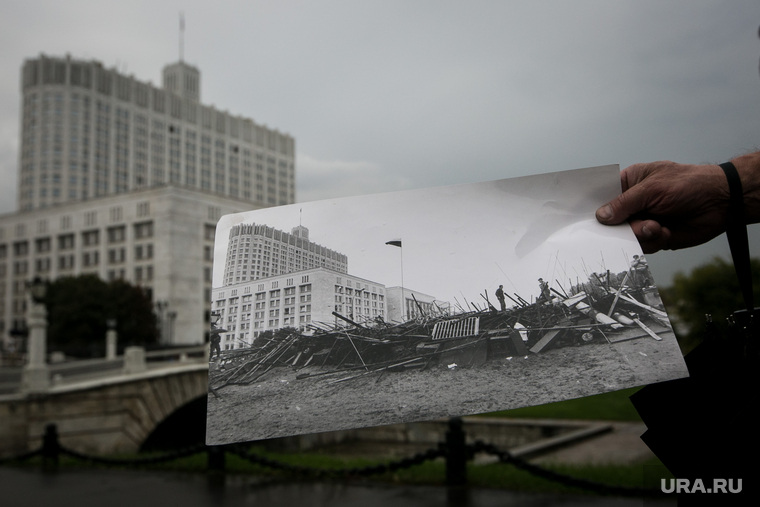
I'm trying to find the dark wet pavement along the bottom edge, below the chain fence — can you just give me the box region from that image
[0,467,675,507]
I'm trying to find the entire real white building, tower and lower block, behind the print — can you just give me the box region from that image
[0,55,295,347]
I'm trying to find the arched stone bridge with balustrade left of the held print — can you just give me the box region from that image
[0,347,208,457]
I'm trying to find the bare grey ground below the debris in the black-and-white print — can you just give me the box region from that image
[207,329,682,444]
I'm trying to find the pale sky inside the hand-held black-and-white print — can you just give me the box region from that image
[214,165,641,306]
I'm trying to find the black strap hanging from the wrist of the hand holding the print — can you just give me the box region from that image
[720,162,755,314]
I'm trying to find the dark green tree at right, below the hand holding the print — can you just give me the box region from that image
[660,257,760,352]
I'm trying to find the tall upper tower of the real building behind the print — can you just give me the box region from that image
[18,55,295,211]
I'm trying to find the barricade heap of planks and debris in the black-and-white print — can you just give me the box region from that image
[210,273,670,394]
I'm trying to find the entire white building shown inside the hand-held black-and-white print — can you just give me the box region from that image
[212,223,450,350]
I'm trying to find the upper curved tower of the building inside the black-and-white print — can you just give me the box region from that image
[223,224,348,286]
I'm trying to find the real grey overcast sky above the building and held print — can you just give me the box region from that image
[0,0,760,284]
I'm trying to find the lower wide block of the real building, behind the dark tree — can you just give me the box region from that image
[0,187,255,346]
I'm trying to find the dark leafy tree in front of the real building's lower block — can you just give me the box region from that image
[45,275,158,357]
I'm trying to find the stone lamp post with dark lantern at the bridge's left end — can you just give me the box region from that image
[21,277,50,392]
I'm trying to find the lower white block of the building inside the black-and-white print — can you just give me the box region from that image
[213,267,386,350]
